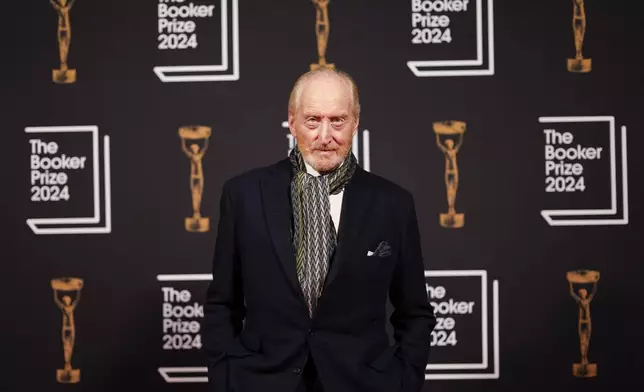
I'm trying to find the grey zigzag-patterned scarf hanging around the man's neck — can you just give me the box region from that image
[289,147,357,317]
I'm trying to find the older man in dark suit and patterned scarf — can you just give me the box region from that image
[204,69,435,392]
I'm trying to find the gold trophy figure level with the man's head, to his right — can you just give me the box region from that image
[433,121,465,229]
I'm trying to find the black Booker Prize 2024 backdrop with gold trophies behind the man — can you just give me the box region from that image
[0,0,644,392]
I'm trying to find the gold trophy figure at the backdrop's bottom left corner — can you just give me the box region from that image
[51,278,83,384]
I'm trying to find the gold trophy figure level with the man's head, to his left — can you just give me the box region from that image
[179,125,212,232]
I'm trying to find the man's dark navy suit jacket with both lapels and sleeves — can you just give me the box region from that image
[204,159,435,392]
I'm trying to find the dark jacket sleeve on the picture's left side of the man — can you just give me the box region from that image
[203,184,246,389]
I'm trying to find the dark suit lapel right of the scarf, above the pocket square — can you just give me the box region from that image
[324,166,374,290]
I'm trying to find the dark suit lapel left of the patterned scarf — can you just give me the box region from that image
[261,159,304,303]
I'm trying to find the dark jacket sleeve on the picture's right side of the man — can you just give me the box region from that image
[389,194,436,392]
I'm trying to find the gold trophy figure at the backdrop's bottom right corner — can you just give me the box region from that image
[566,270,599,377]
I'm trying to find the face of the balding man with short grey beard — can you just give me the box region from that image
[288,74,358,174]
